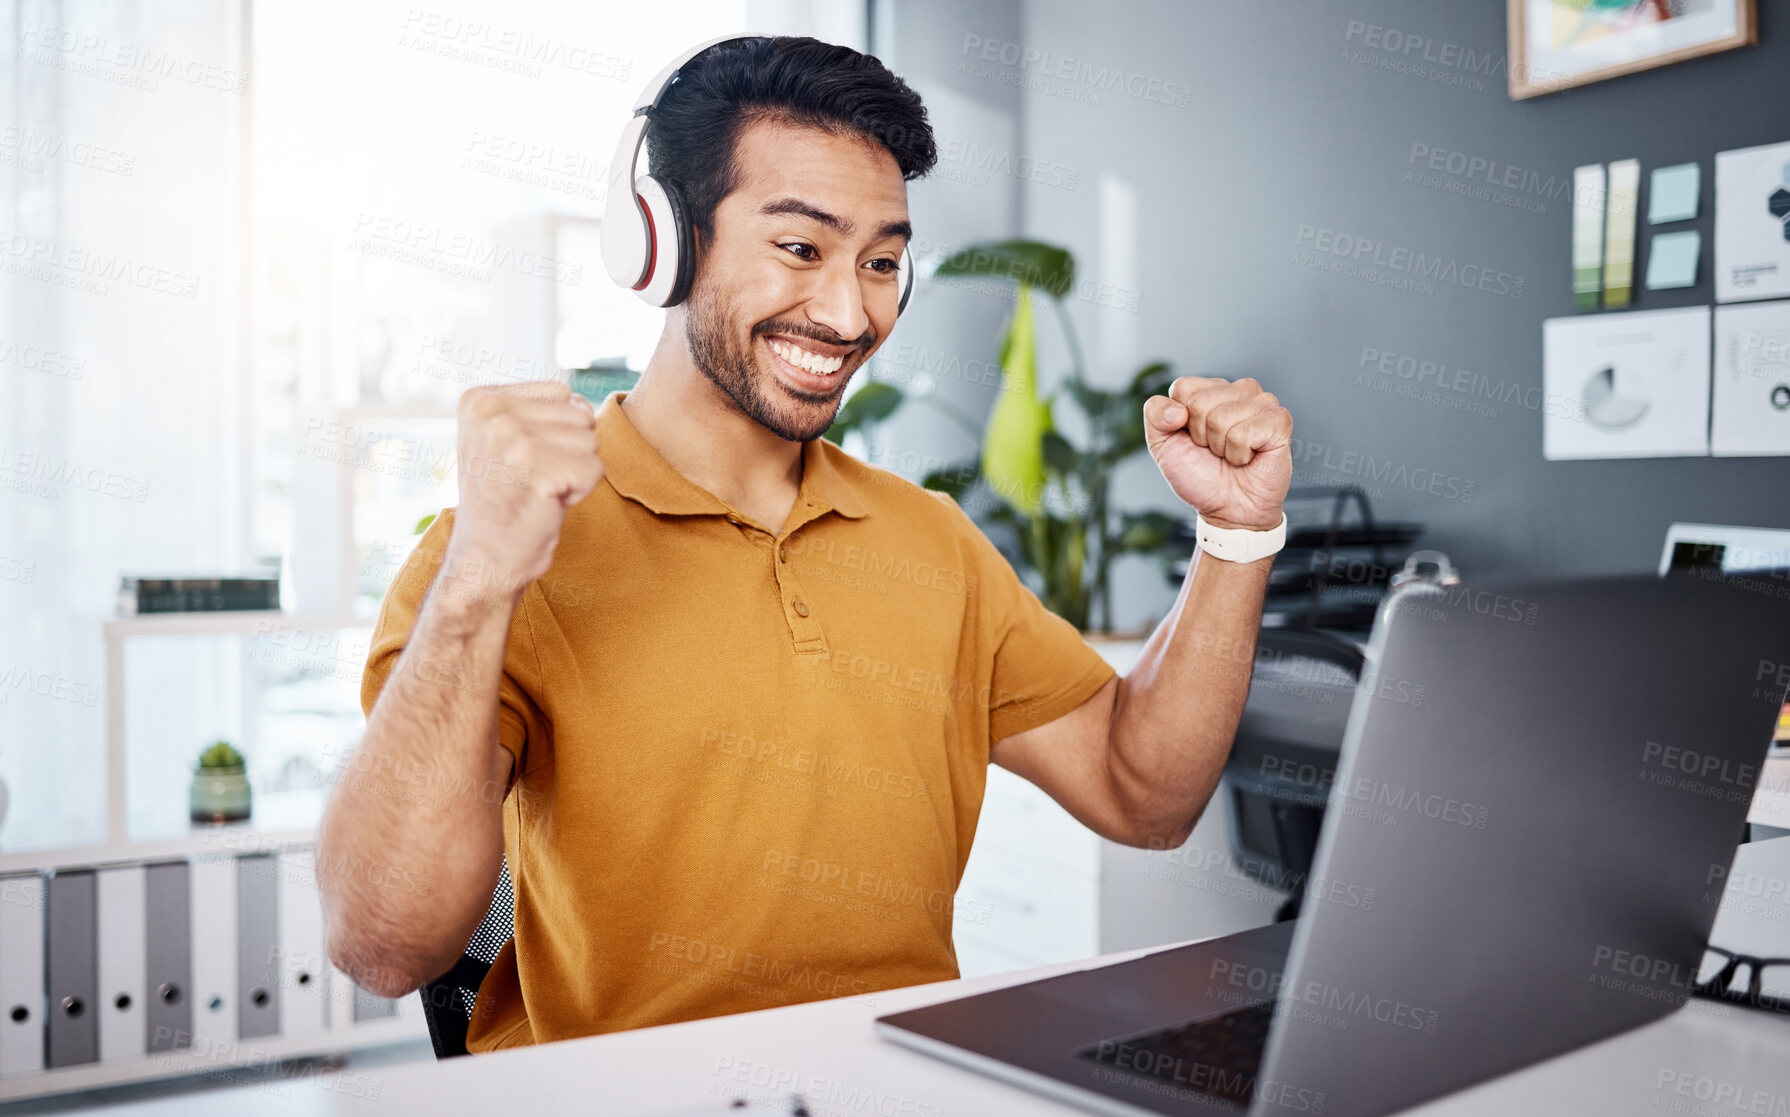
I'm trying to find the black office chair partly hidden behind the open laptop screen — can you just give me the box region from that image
[1223,628,1364,920]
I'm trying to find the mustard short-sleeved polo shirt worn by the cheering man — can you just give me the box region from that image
[362,392,1113,1051]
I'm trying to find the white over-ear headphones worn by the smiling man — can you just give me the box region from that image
[598,36,913,317]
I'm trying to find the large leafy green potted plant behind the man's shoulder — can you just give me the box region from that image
[827,240,1178,632]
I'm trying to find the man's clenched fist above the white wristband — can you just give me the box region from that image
[1144,376,1292,532]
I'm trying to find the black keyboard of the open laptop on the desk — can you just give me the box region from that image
[1076,1001,1274,1104]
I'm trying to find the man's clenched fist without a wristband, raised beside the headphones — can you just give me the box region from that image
[446,381,603,594]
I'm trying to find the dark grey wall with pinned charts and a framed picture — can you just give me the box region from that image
[879,0,1790,625]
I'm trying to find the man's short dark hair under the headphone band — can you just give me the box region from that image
[646,36,938,238]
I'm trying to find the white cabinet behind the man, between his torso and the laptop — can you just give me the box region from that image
[954,641,1285,977]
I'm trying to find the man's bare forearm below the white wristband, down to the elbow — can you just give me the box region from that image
[1106,550,1273,848]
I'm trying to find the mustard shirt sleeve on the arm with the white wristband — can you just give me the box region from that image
[938,492,1119,743]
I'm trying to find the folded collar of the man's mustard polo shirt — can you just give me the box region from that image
[596,390,868,519]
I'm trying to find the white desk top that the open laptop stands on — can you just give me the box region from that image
[90,838,1790,1117]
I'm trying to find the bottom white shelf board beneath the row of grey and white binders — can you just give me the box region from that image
[0,993,433,1101]
